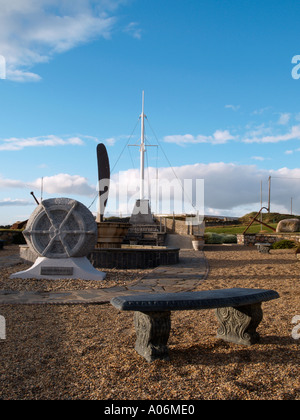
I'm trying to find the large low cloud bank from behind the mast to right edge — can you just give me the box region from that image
[108,162,300,216]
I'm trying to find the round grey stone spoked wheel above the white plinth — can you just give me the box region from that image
[23,198,97,258]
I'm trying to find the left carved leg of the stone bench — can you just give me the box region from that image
[134,311,171,362]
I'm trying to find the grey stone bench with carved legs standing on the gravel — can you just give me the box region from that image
[111,288,279,362]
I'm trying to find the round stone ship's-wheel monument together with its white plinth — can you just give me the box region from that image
[10,198,106,280]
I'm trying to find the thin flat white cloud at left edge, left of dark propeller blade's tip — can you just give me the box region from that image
[0,135,84,151]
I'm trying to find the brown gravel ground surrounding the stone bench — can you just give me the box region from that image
[0,246,300,400]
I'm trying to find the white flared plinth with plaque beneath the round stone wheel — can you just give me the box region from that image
[10,257,106,281]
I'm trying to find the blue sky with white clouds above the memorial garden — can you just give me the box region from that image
[0,0,300,224]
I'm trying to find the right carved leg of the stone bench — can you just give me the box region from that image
[216,303,263,346]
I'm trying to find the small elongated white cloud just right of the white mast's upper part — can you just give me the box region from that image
[164,130,235,146]
